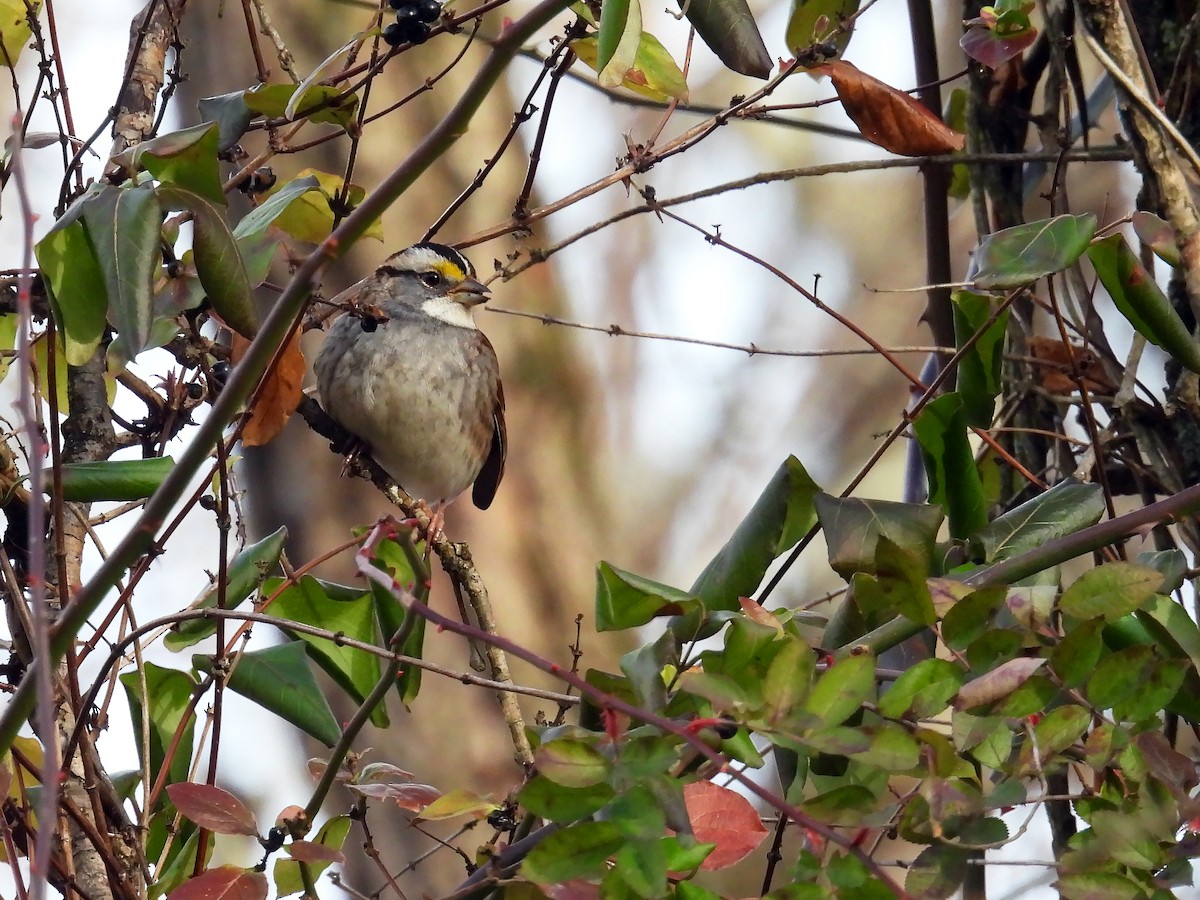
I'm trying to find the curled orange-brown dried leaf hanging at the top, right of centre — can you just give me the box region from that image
[812,60,966,156]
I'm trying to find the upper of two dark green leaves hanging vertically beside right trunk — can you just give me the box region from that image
[950,290,1009,428]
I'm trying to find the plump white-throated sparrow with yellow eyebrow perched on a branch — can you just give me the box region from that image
[313,241,508,520]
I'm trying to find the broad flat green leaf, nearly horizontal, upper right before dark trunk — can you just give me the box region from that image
[974,212,1096,290]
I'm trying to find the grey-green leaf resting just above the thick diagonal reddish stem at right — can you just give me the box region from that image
[971,479,1105,563]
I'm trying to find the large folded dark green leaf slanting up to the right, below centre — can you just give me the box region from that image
[671,456,821,638]
